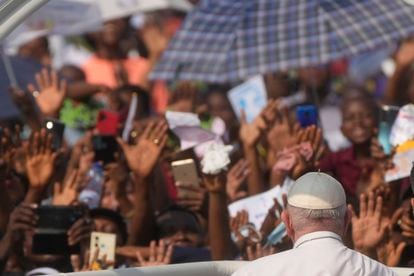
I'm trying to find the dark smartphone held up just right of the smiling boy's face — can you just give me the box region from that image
[378,105,399,155]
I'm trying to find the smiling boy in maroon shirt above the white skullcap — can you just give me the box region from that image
[319,89,378,197]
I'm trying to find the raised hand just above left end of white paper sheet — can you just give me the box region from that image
[226,159,249,201]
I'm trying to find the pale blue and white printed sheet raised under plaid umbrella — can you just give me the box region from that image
[228,75,267,123]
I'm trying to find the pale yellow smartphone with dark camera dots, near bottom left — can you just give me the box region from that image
[89,232,116,268]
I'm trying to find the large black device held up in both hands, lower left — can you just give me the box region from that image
[32,206,86,255]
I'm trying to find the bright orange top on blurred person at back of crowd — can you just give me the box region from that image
[82,55,150,88]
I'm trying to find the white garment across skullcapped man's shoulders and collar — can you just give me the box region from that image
[232,231,397,276]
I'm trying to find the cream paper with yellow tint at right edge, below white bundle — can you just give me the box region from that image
[385,149,414,182]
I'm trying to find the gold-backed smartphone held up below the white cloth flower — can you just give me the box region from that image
[171,159,199,186]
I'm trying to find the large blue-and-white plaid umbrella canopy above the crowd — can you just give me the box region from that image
[151,0,414,82]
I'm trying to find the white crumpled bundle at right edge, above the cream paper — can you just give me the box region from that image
[390,104,414,147]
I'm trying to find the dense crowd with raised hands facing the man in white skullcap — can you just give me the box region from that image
[0,3,414,273]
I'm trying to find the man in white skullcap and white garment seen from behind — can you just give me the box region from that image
[232,172,397,276]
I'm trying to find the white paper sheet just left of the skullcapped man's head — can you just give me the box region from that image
[228,179,293,229]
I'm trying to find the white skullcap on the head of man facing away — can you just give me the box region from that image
[288,172,346,210]
